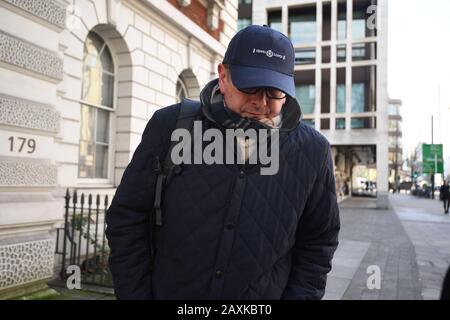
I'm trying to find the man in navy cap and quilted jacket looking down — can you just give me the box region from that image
[106,26,340,299]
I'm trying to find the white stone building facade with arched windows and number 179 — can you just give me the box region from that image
[0,0,237,296]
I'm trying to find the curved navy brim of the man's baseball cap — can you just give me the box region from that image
[230,65,295,99]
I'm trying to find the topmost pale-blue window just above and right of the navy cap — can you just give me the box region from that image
[289,6,316,46]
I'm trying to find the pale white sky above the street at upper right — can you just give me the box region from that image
[388,0,450,165]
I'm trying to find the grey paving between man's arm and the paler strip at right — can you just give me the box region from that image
[324,198,422,300]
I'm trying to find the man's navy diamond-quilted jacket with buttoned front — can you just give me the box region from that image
[106,79,340,299]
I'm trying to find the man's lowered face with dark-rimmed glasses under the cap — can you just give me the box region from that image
[218,64,286,120]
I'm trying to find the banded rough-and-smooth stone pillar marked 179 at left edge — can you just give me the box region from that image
[0,0,66,292]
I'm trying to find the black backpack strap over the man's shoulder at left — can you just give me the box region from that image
[153,99,201,226]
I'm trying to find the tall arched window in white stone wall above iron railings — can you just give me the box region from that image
[78,32,114,179]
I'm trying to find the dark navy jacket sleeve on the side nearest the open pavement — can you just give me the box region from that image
[283,144,340,300]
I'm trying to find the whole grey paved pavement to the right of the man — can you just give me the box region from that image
[324,194,450,300]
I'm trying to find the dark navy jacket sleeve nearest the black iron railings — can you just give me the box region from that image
[106,112,170,299]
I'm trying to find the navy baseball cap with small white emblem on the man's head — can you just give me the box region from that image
[223,25,295,99]
